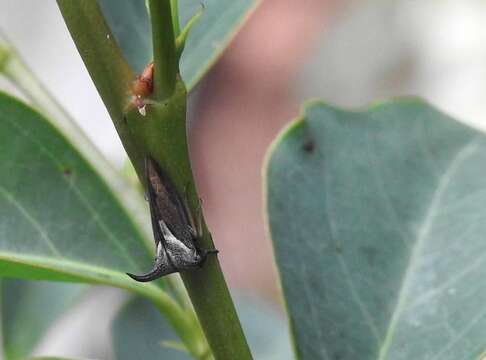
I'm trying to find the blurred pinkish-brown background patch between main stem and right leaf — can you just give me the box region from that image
[190,0,332,298]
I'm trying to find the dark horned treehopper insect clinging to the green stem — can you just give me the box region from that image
[128,157,218,282]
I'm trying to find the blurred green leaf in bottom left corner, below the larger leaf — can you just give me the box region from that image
[1,279,86,360]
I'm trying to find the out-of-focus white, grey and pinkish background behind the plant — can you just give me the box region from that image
[0,0,486,358]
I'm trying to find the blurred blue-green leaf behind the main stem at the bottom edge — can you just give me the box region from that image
[112,296,292,360]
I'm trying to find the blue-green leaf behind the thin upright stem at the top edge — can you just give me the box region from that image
[99,0,259,92]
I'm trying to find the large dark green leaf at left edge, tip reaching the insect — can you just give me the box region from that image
[0,94,150,283]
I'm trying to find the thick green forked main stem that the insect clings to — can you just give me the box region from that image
[58,0,251,360]
